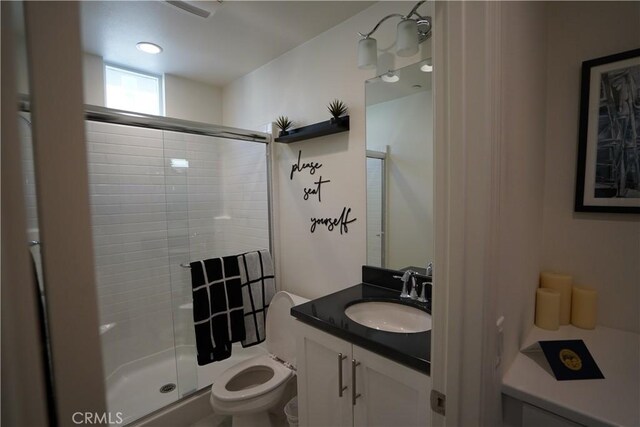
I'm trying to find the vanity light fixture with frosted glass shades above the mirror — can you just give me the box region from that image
[358,0,431,70]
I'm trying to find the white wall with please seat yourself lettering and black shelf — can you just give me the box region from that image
[223,2,429,298]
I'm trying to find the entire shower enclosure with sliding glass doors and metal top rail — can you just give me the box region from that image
[22,106,271,423]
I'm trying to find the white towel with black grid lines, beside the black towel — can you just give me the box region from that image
[238,250,276,347]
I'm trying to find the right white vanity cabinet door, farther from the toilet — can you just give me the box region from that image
[353,345,431,427]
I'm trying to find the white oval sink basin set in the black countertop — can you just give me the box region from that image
[344,301,431,334]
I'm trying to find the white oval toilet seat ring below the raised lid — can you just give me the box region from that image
[211,355,293,402]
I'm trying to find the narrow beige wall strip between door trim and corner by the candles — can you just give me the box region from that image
[496,2,551,374]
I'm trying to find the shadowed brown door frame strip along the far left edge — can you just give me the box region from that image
[0,2,52,425]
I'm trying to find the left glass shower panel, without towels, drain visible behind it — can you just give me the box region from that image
[86,121,179,423]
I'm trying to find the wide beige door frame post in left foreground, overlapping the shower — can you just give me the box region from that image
[24,2,106,425]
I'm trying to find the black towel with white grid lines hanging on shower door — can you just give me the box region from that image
[191,256,245,365]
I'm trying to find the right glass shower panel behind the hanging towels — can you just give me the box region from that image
[165,132,270,395]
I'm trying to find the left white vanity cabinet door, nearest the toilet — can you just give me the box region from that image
[295,321,353,427]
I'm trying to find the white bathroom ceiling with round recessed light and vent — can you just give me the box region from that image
[81,0,374,86]
